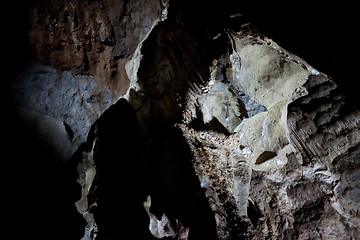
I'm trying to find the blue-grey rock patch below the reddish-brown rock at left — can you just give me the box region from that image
[12,63,115,161]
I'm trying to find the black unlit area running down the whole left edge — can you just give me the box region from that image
[0,0,86,234]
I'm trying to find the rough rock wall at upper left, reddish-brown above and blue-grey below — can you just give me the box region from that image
[11,0,167,161]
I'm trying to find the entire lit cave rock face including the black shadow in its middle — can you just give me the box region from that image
[11,0,360,240]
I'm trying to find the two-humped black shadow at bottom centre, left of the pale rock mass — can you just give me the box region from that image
[94,99,217,240]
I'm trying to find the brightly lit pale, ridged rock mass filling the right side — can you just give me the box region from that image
[179,34,360,239]
